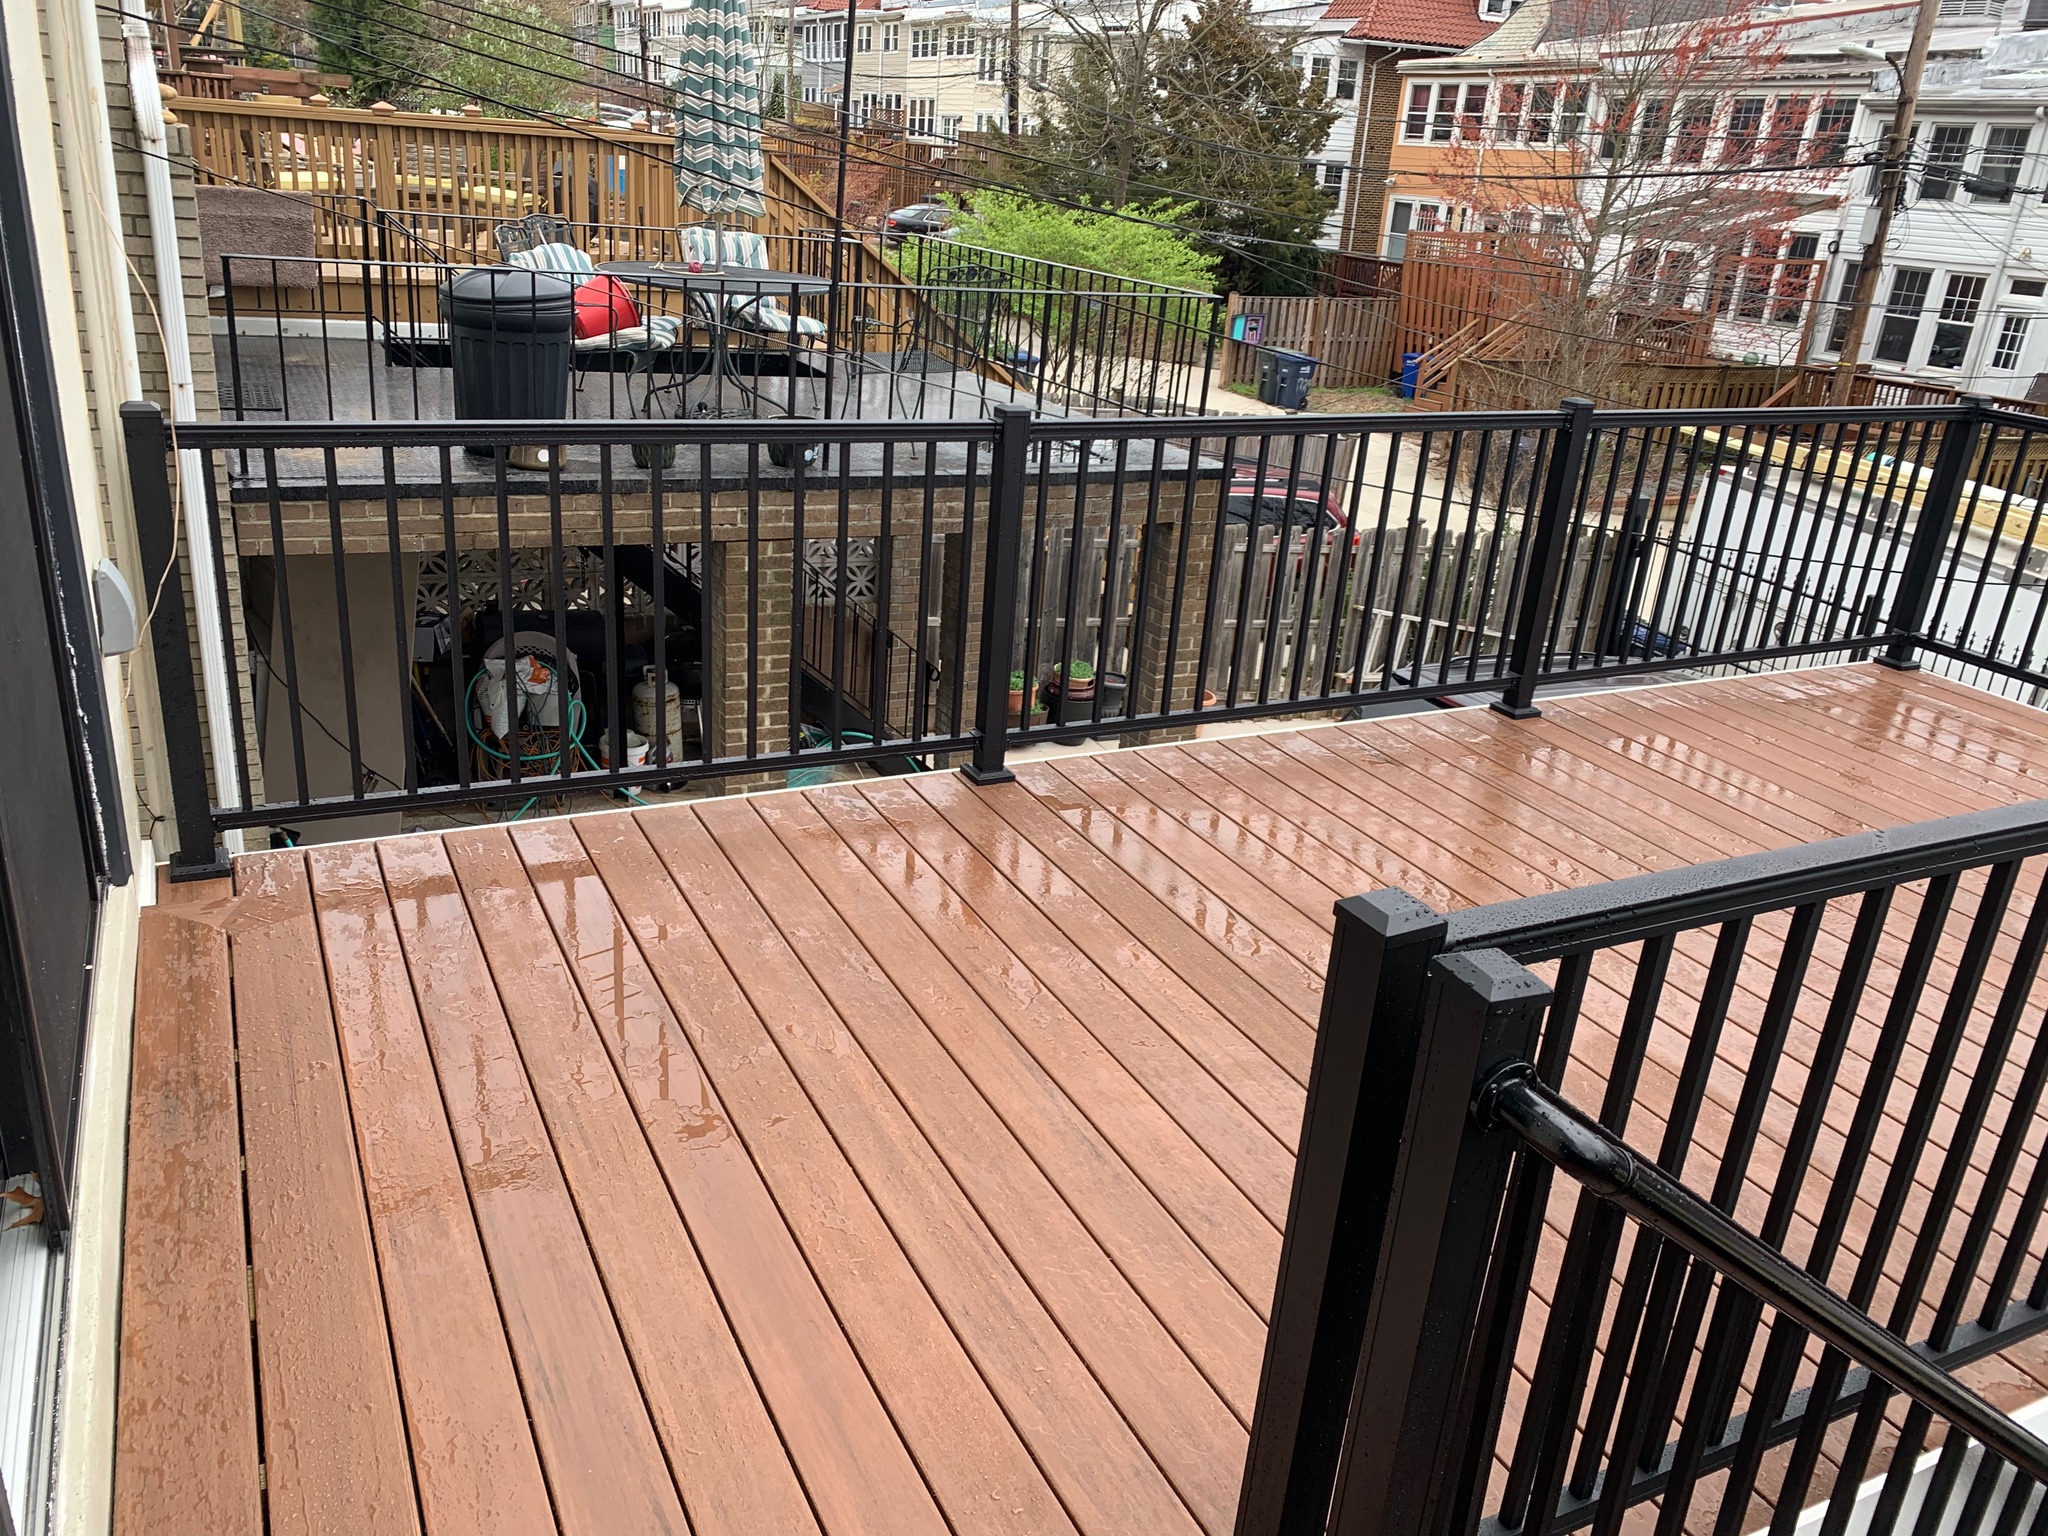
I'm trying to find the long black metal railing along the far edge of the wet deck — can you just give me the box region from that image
[129,391,2048,872]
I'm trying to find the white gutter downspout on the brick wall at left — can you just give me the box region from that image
[120,0,242,854]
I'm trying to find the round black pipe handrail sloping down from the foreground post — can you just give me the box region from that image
[1473,1061,2048,1483]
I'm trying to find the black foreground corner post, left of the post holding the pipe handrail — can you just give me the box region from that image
[1237,891,1444,1536]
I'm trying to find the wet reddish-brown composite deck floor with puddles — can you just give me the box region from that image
[115,668,2048,1536]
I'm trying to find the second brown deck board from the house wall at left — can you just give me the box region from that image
[229,854,420,1536]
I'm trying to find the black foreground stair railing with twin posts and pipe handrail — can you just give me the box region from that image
[1237,801,2048,1536]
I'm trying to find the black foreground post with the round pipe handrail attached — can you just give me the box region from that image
[1329,950,1550,1536]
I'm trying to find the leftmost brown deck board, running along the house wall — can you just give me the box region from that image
[113,881,262,1536]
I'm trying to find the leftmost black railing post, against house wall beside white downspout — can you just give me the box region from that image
[121,399,231,881]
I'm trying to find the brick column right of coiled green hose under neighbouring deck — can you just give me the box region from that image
[705,539,795,795]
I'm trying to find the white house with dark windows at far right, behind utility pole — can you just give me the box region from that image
[1812,23,2048,397]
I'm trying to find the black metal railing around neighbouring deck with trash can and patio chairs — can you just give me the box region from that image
[215,241,1221,422]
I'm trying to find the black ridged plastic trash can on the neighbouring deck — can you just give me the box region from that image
[440,266,575,469]
